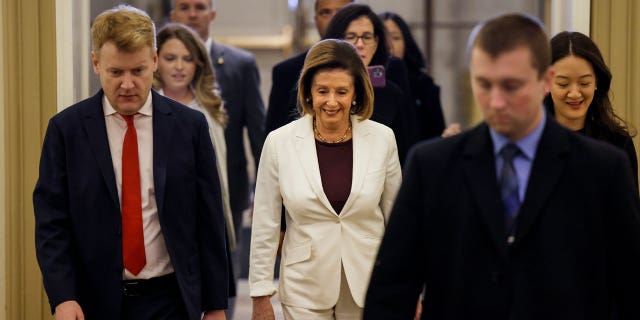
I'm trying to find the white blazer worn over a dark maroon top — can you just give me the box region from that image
[249,115,402,309]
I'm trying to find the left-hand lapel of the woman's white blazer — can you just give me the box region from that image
[292,115,337,215]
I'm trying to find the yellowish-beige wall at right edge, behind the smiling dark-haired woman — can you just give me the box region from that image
[591,0,640,182]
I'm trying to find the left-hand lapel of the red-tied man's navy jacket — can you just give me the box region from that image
[82,90,120,208]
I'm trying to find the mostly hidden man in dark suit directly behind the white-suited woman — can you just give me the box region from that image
[265,0,353,133]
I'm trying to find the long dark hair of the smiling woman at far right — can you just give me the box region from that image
[544,31,635,140]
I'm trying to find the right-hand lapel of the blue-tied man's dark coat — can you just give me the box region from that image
[515,117,569,243]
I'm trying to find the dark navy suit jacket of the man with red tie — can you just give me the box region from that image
[33,91,228,320]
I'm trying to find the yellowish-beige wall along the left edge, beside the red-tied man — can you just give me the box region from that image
[0,0,56,320]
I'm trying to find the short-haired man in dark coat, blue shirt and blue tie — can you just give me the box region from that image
[364,14,640,320]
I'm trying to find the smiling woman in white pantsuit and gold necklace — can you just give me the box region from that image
[249,39,401,319]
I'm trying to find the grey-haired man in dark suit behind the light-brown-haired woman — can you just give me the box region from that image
[171,0,265,318]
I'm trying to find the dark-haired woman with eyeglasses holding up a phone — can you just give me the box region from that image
[324,3,418,163]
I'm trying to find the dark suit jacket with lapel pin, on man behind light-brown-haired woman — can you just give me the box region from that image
[210,42,265,235]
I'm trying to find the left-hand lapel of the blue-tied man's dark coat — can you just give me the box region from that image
[462,123,506,257]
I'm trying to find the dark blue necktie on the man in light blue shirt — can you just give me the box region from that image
[500,143,520,234]
